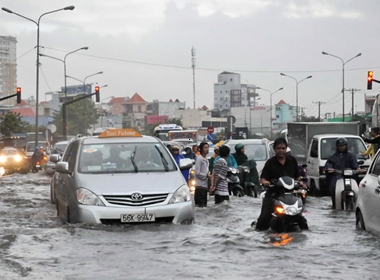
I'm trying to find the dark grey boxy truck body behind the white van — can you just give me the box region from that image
[286,122,361,164]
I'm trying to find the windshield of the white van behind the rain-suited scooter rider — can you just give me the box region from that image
[321,137,368,159]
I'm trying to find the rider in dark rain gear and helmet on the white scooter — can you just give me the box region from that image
[325,137,361,209]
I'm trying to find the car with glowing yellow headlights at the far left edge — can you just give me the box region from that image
[0,147,30,175]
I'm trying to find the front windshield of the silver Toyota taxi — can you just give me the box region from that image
[78,143,177,174]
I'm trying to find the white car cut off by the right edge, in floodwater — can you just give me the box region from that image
[355,149,380,236]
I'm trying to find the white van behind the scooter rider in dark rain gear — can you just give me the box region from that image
[307,134,371,194]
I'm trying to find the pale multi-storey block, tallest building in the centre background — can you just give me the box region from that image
[214,71,258,110]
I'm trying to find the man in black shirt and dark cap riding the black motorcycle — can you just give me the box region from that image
[256,138,303,230]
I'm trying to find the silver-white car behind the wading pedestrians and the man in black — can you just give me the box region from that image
[224,138,274,174]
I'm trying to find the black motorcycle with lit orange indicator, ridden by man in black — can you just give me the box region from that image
[260,176,309,232]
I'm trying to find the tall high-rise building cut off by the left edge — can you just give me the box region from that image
[0,36,17,105]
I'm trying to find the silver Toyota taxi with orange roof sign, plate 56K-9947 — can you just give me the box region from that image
[55,129,194,224]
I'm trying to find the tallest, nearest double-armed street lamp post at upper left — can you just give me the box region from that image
[1,6,75,146]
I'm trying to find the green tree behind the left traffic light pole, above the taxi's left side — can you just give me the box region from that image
[53,98,99,135]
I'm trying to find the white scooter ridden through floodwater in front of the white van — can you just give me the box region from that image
[334,168,360,210]
